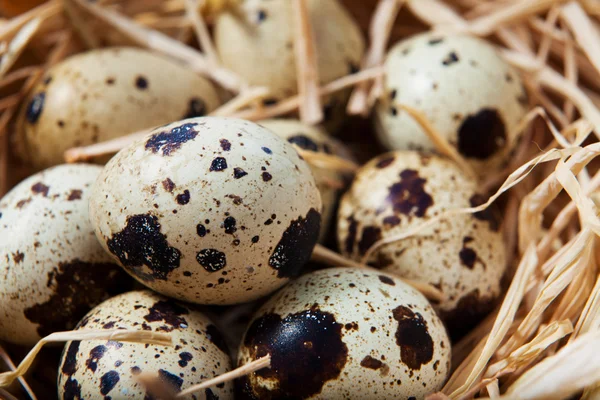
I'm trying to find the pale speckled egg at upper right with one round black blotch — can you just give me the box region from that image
[375,33,528,174]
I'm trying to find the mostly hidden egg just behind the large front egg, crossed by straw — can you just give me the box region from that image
[259,119,350,242]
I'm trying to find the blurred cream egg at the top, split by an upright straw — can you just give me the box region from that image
[214,0,365,126]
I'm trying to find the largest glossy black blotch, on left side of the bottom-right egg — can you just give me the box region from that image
[244,306,348,399]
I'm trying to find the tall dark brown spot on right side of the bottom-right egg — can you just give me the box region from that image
[393,306,433,370]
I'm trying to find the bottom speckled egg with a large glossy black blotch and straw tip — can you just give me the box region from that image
[238,268,451,399]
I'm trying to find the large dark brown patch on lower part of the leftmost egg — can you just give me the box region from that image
[24,259,132,337]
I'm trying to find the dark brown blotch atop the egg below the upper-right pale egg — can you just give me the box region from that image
[386,169,433,217]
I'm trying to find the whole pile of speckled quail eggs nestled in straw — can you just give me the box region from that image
[0,0,527,400]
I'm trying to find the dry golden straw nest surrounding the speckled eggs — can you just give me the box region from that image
[0,0,600,399]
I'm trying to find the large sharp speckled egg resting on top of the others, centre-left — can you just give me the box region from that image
[90,117,321,304]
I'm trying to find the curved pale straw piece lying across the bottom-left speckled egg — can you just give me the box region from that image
[0,329,173,387]
